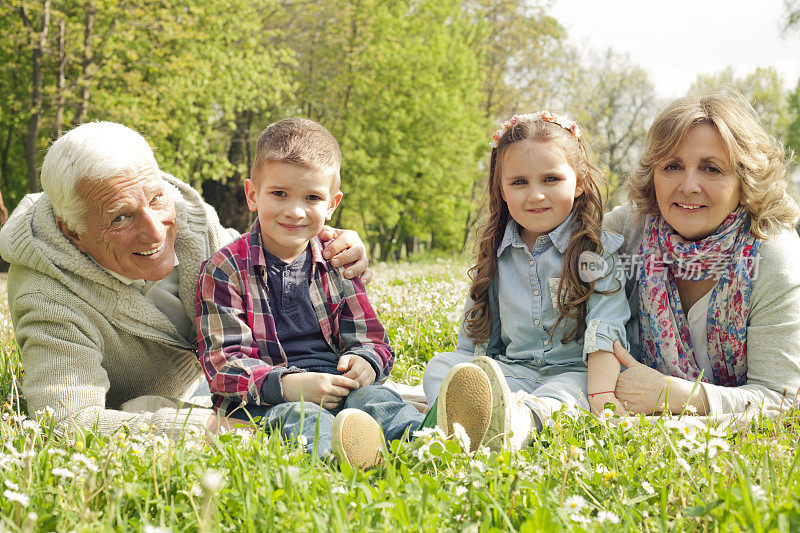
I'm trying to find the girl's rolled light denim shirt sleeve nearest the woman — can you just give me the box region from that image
[583,231,631,361]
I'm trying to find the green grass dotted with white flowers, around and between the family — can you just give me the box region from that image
[0,260,800,532]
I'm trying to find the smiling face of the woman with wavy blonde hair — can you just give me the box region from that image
[653,123,741,241]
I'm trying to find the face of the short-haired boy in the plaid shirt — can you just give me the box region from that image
[244,162,342,262]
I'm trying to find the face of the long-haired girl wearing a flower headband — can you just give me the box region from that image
[500,141,583,249]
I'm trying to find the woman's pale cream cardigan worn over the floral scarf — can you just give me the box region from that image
[603,204,800,417]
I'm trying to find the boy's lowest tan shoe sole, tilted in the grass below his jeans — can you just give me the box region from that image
[331,409,386,469]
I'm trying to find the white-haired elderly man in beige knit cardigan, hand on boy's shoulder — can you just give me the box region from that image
[0,122,369,434]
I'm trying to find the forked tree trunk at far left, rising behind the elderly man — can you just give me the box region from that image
[20,0,50,192]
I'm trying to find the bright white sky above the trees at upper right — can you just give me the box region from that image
[549,0,800,98]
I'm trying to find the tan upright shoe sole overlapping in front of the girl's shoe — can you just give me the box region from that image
[436,363,492,452]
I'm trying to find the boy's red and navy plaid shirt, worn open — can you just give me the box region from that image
[196,219,394,413]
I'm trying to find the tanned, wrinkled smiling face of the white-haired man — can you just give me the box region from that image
[61,165,180,281]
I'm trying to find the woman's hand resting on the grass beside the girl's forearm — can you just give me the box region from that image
[614,341,708,415]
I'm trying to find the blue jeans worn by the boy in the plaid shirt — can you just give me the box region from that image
[228,385,422,458]
